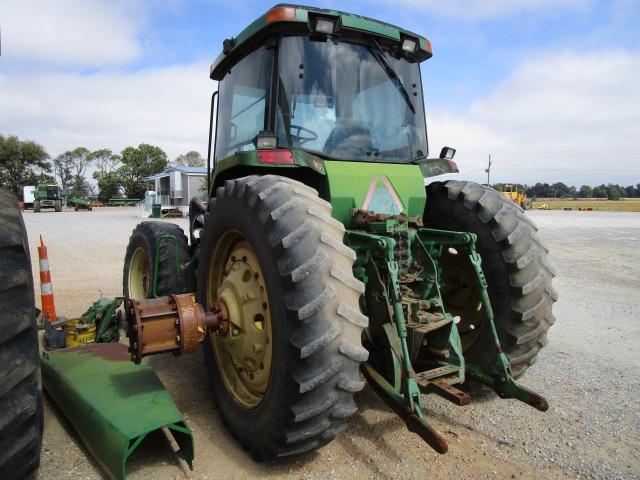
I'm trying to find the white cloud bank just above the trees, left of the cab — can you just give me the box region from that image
[0,62,215,158]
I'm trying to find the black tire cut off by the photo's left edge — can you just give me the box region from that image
[0,190,43,479]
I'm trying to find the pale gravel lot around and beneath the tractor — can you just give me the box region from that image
[24,209,640,479]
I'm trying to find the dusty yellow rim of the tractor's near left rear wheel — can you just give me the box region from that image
[207,232,273,409]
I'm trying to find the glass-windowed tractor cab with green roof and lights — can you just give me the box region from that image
[211,5,457,200]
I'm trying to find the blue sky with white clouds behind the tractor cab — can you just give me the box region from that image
[0,0,640,184]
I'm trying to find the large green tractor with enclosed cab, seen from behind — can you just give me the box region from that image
[123,5,557,460]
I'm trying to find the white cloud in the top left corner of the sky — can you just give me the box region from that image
[0,0,142,67]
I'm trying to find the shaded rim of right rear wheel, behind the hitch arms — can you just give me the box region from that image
[439,247,485,351]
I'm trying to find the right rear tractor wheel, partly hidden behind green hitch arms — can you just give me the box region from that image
[424,181,558,384]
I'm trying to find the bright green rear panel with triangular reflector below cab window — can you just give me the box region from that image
[324,160,426,225]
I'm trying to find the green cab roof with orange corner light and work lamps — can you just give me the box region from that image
[210,3,432,80]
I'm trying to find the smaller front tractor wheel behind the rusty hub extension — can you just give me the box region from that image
[122,222,191,300]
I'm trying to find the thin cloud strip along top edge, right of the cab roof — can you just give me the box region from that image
[378,0,593,20]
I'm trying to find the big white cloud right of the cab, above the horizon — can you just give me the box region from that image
[428,50,640,183]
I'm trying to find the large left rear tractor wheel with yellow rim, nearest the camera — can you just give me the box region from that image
[198,175,368,461]
